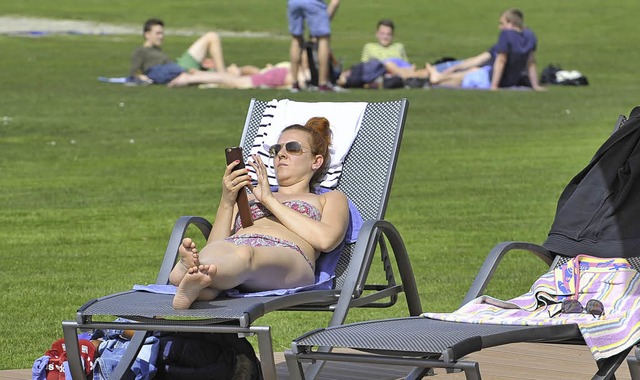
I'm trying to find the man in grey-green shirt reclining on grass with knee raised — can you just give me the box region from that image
[129,18,232,84]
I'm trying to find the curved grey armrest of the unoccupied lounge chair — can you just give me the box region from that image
[462,241,555,305]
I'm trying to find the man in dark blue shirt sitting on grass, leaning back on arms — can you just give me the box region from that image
[427,8,545,91]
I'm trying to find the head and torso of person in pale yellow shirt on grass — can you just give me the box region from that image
[360,19,410,67]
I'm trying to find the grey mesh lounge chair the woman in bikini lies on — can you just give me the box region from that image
[62,99,421,379]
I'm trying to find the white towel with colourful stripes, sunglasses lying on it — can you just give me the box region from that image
[423,255,640,360]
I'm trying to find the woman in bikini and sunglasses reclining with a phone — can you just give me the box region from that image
[170,117,349,309]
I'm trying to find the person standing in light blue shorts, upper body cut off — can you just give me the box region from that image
[287,0,340,92]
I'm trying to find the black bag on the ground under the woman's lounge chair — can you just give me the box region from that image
[155,333,263,380]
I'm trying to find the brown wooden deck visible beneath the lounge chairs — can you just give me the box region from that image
[0,343,631,380]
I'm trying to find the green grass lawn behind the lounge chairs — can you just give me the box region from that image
[0,0,640,369]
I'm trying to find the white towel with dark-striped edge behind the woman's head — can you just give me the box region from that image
[251,99,367,189]
